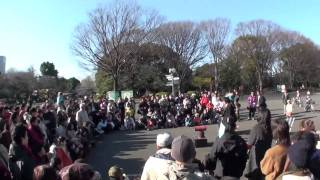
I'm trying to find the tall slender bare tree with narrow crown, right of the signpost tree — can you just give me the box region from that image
[201,18,230,91]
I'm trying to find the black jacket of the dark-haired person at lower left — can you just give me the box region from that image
[9,143,36,180]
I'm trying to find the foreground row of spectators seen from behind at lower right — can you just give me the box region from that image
[141,108,320,180]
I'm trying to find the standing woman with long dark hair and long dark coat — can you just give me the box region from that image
[246,104,272,180]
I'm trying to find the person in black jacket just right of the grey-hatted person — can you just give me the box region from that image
[204,124,247,179]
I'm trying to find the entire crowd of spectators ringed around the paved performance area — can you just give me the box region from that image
[0,90,320,180]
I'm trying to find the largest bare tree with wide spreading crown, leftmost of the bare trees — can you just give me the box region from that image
[71,0,160,90]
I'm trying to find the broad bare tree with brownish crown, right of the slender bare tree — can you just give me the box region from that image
[236,20,280,91]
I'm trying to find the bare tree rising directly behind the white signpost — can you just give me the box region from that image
[156,21,207,90]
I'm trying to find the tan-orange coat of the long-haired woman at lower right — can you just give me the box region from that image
[260,145,288,180]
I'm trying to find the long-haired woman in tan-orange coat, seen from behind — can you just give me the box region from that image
[260,120,290,180]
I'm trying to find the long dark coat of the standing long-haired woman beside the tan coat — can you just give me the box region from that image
[246,124,272,179]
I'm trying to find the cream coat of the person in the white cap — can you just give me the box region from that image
[141,148,173,180]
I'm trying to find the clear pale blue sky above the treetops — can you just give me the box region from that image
[0,0,320,80]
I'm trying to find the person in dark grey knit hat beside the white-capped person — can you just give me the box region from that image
[166,135,213,180]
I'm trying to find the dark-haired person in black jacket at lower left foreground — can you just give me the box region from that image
[9,124,36,180]
